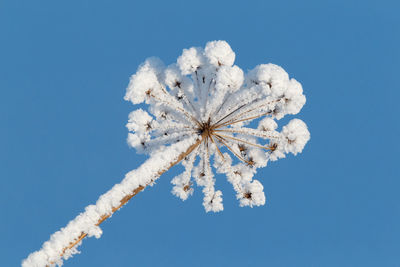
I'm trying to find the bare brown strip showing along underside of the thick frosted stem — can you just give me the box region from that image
[46,139,203,267]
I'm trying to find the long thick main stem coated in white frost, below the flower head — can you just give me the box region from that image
[22,138,202,267]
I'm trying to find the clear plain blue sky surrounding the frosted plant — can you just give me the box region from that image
[0,0,400,267]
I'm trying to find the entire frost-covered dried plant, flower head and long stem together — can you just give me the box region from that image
[22,41,310,267]
